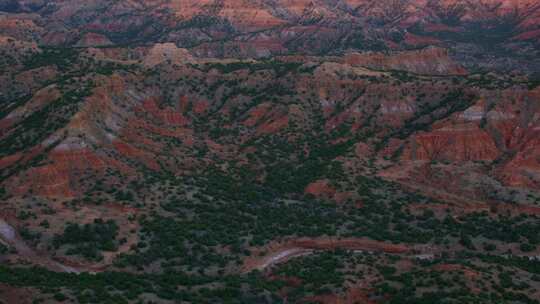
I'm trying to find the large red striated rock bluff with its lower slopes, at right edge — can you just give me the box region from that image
[381,85,540,207]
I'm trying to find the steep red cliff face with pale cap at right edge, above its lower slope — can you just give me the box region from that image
[394,88,538,170]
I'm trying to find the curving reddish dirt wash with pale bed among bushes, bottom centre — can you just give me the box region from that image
[242,238,412,272]
